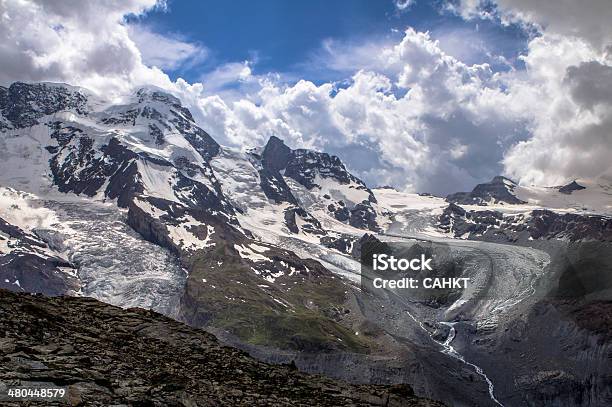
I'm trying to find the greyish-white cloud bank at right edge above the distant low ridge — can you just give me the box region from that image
[504,35,612,185]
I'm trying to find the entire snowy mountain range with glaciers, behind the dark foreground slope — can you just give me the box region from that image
[0,82,612,406]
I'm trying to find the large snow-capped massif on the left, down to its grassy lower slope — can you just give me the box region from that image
[0,83,390,354]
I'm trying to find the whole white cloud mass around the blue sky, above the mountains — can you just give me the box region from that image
[0,0,612,194]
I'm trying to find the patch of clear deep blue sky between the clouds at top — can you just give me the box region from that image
[129,0,529,83]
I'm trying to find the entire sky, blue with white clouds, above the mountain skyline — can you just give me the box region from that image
[0,0,612,194]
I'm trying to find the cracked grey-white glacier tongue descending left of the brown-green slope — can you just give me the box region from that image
[36,201,187,317]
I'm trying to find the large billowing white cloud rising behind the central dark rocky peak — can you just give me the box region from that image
[190,29,525,193]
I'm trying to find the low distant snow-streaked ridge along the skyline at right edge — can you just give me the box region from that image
[439,176,612,241]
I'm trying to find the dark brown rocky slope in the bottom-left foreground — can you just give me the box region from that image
[0,290,441,407]
